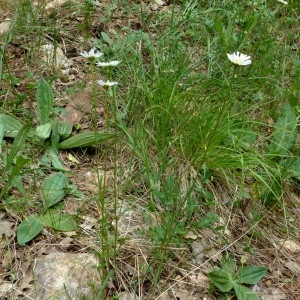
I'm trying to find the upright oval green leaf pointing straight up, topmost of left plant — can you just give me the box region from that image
[36,78,53,125]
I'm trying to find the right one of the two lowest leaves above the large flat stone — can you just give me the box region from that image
[43,210,77,231]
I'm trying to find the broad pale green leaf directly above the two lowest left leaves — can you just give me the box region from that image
[41,172,68,209]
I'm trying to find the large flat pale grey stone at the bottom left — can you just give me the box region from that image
[33,253,100,300]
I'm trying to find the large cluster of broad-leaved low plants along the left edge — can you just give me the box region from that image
[0,78,113,244]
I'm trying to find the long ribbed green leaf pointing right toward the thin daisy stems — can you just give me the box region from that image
[58,132,114,149]
